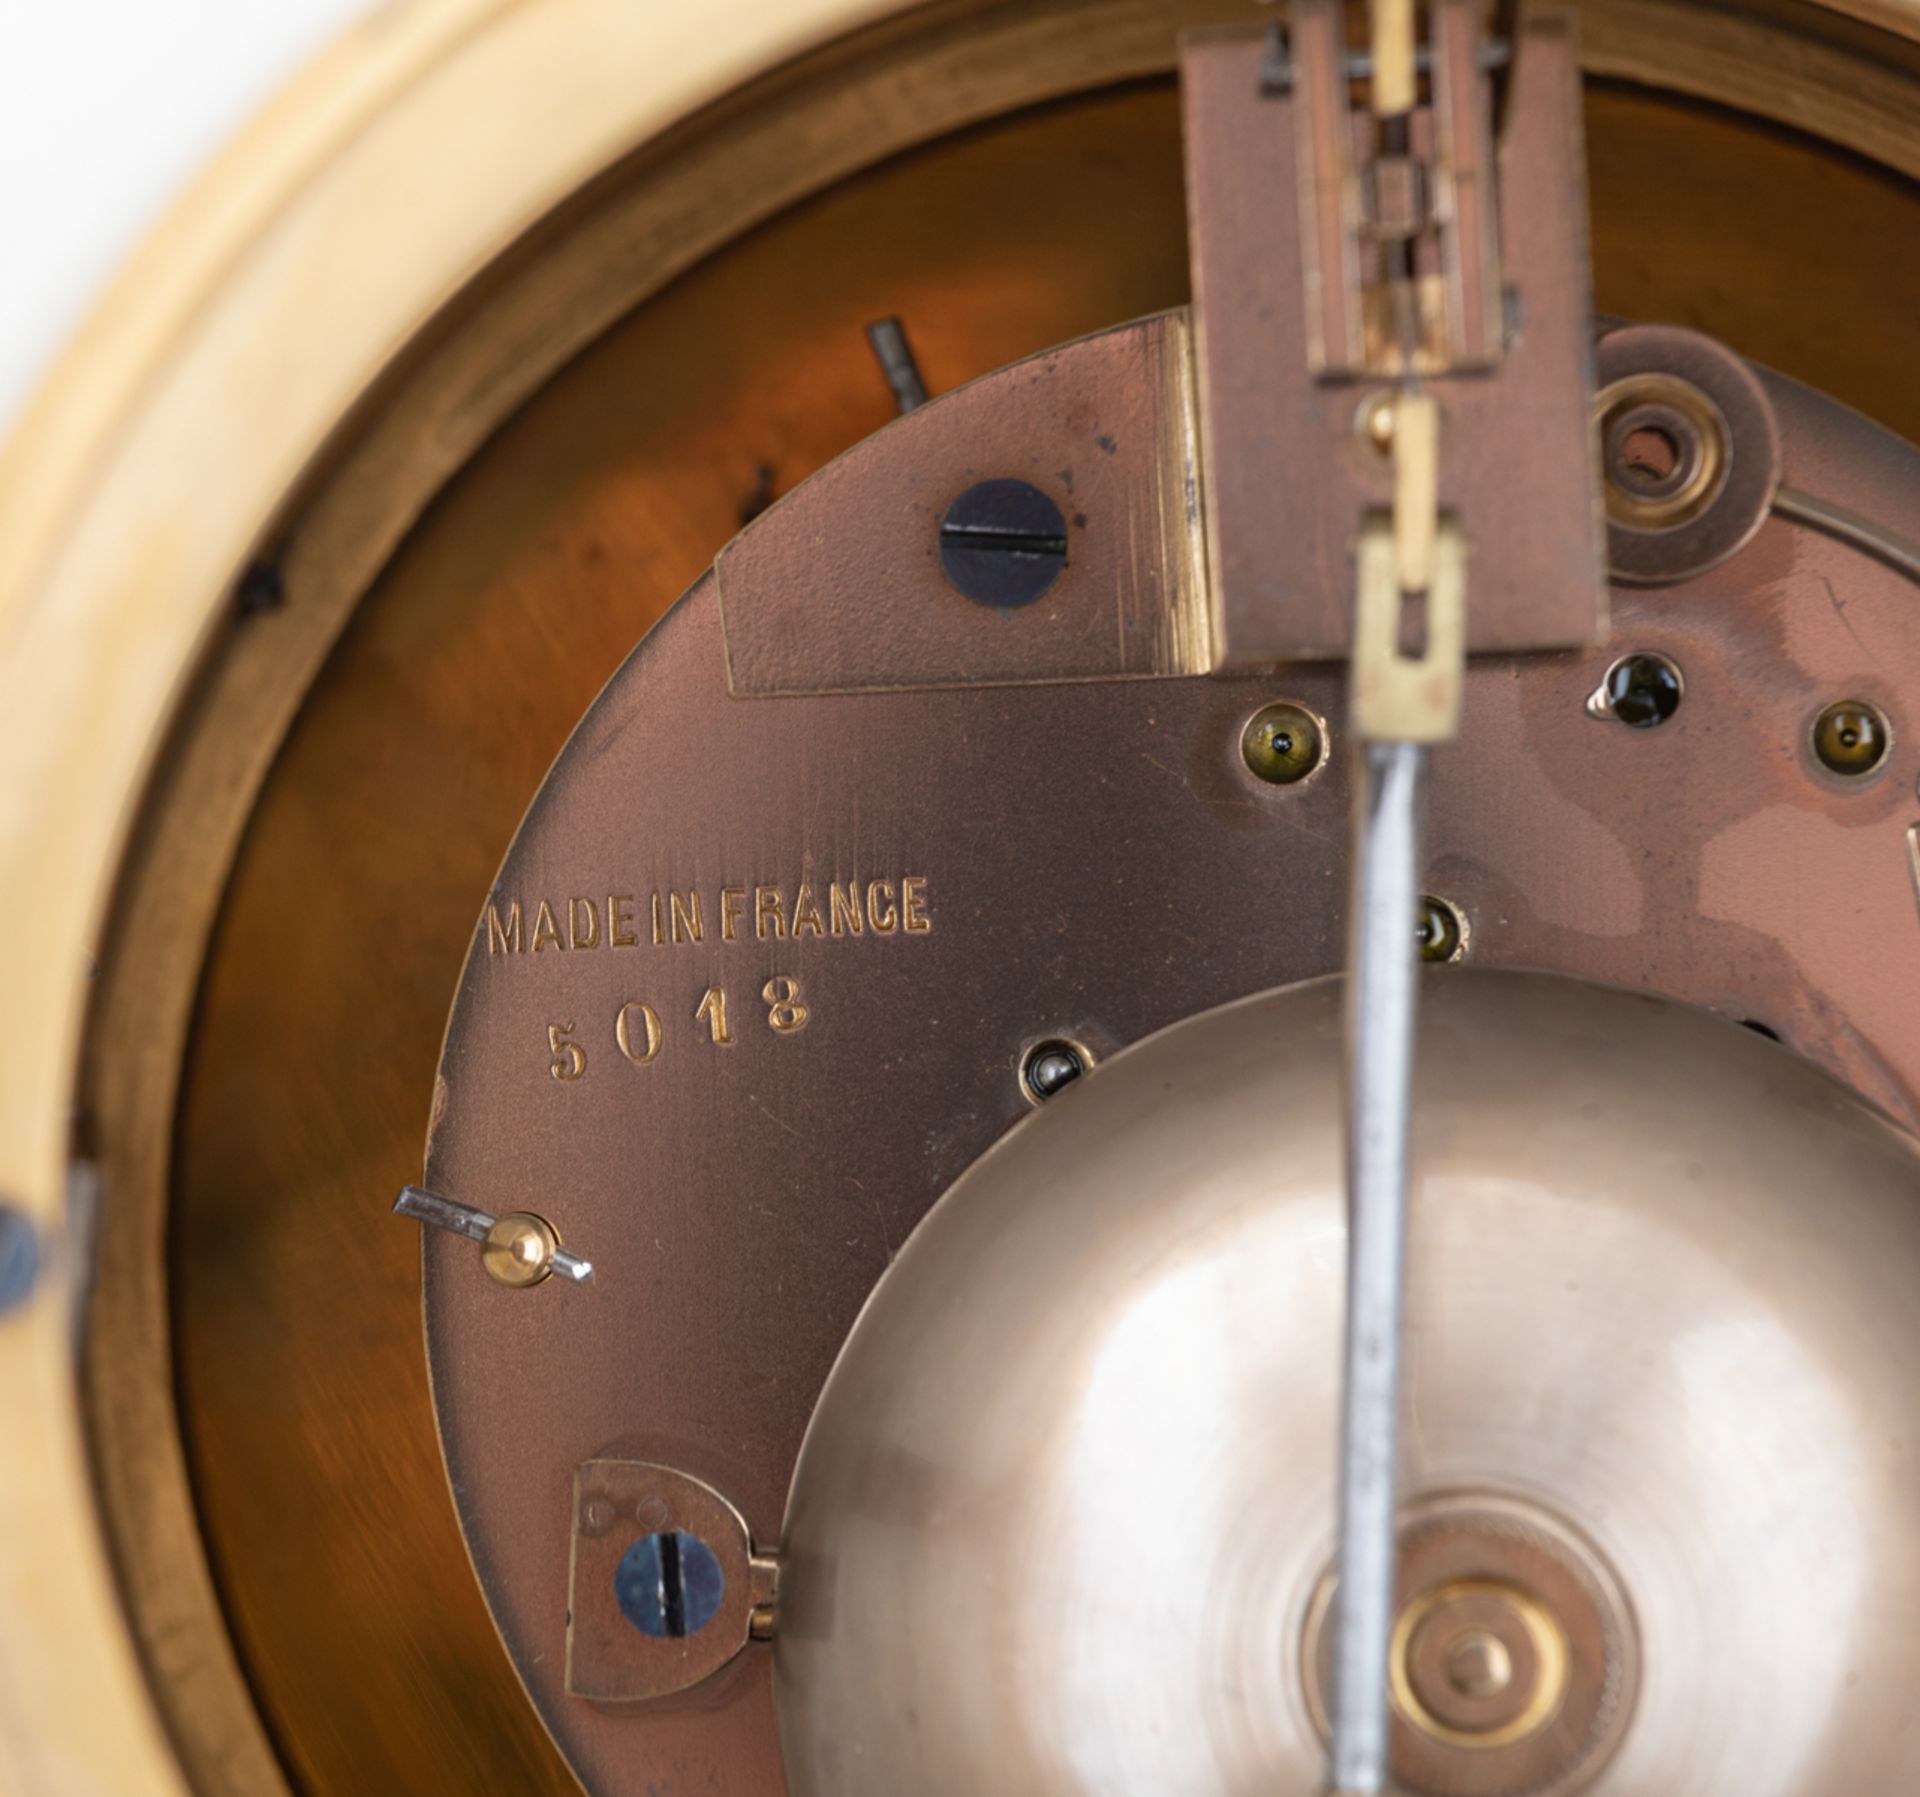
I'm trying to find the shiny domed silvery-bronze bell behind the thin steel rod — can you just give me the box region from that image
[776,970,1920,1797]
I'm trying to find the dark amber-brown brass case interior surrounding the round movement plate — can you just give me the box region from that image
[74,52,1920,1793]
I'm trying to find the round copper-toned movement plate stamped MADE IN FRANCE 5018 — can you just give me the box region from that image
[424,326,1920,1797]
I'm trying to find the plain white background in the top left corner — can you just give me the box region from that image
[0,0,367,434]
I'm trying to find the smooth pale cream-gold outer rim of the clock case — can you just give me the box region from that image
[0,0,899,1797]
